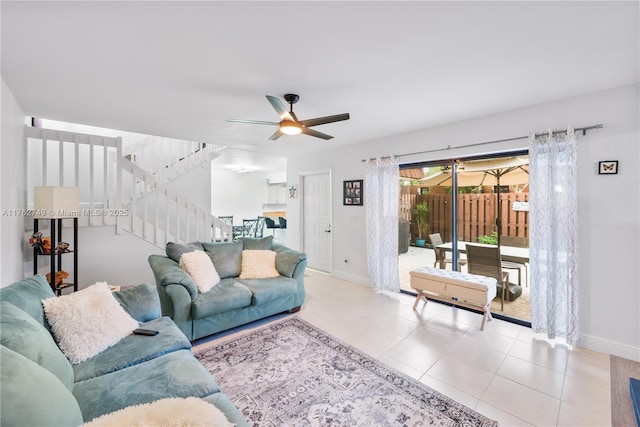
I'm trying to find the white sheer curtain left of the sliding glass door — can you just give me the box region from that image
[364,157,400,292]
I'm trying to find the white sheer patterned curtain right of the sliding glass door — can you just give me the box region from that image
[529,128,578,345]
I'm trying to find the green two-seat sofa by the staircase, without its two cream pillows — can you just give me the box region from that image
[149,236,307,340]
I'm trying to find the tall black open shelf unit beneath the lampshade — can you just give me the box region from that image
[33,218,78,296]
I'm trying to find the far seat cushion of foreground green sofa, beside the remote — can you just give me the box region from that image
[73,317,191,382]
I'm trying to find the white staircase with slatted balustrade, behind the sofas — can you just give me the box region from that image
[24,126,232,249]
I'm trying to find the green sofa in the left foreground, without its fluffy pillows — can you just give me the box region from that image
[0,275,247,426]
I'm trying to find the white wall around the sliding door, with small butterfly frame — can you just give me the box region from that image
[287,85,640,360]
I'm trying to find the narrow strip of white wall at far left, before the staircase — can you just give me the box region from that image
[0,79,26,287]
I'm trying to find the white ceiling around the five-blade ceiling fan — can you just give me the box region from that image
[0,1,640,171]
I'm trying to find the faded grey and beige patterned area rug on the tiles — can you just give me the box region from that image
[195,317,498,427]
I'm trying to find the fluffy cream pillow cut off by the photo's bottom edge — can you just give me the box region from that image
[84,397,235,427]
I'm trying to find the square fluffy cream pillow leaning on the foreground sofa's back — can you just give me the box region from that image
[42,282,138,364]
